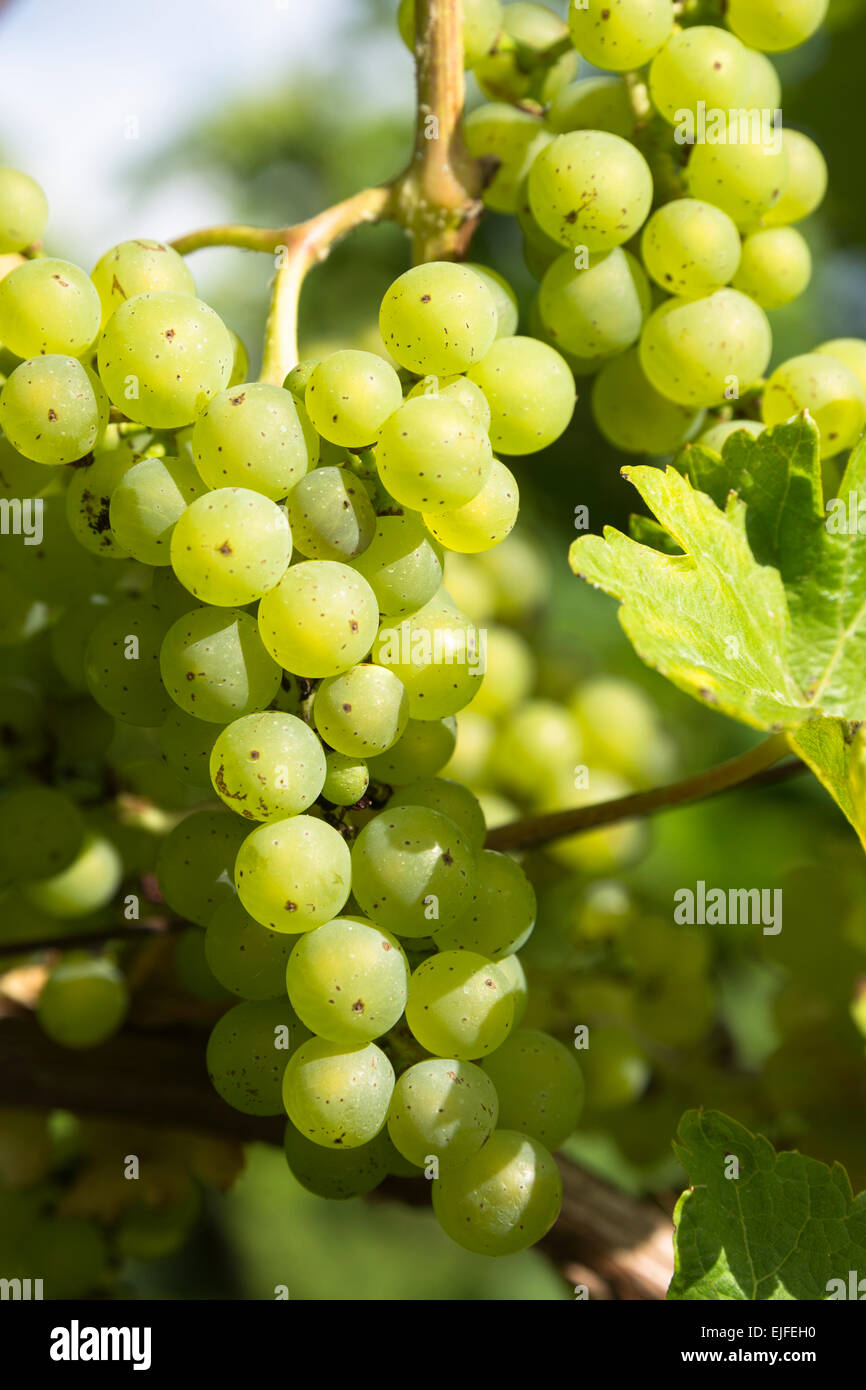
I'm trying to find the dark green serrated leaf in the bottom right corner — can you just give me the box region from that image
[667,1111,866,1301]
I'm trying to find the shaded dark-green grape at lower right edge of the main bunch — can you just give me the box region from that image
[484,1029,584,1152]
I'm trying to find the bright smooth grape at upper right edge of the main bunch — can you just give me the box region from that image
[468,338,575,455]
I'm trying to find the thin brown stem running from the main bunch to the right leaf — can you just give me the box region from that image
[487,734,806,851]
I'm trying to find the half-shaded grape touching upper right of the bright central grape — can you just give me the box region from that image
[352,512,442,617]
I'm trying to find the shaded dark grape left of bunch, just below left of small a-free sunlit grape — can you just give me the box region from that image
[156,809,247,927]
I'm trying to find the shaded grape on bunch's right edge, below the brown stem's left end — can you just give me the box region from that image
[436,850,541,961]
